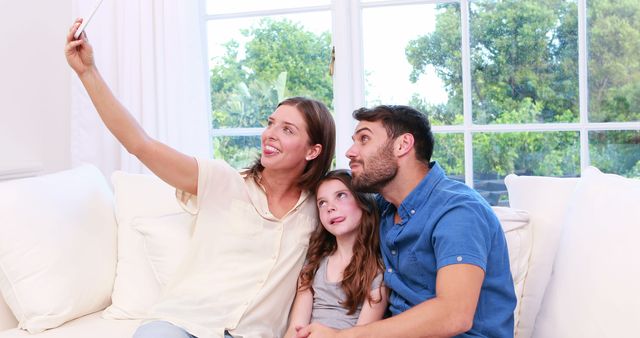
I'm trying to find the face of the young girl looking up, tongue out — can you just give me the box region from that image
[316,179,362,238]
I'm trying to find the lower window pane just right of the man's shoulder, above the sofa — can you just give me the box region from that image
[473,131,580,205]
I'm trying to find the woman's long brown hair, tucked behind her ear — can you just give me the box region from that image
[249,97,336,190]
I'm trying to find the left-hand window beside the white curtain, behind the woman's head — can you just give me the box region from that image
[205,0,333,168]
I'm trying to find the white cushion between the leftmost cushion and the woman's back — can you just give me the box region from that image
[103,171,195,319]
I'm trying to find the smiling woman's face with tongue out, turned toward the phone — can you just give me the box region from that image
[260,105,319,173]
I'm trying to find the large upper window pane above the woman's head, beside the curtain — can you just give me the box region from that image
[208,12,333,128]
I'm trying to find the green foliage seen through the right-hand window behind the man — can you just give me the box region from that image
[406,0,640,179]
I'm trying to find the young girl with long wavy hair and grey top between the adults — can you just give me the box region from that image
[285,170,387,338]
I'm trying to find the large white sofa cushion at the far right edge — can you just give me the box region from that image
[534,167,640,338]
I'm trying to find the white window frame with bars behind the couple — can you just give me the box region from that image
[201,0,640,187]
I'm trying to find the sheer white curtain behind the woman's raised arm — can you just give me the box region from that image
[69,0,212,175]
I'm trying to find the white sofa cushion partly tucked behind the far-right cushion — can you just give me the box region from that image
[505,175,578,338]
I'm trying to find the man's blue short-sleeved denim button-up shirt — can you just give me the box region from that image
[378,162,516,338]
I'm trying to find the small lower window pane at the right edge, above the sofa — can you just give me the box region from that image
[589,130,640,177]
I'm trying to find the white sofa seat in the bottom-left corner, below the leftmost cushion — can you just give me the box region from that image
[0,313,140,338]
